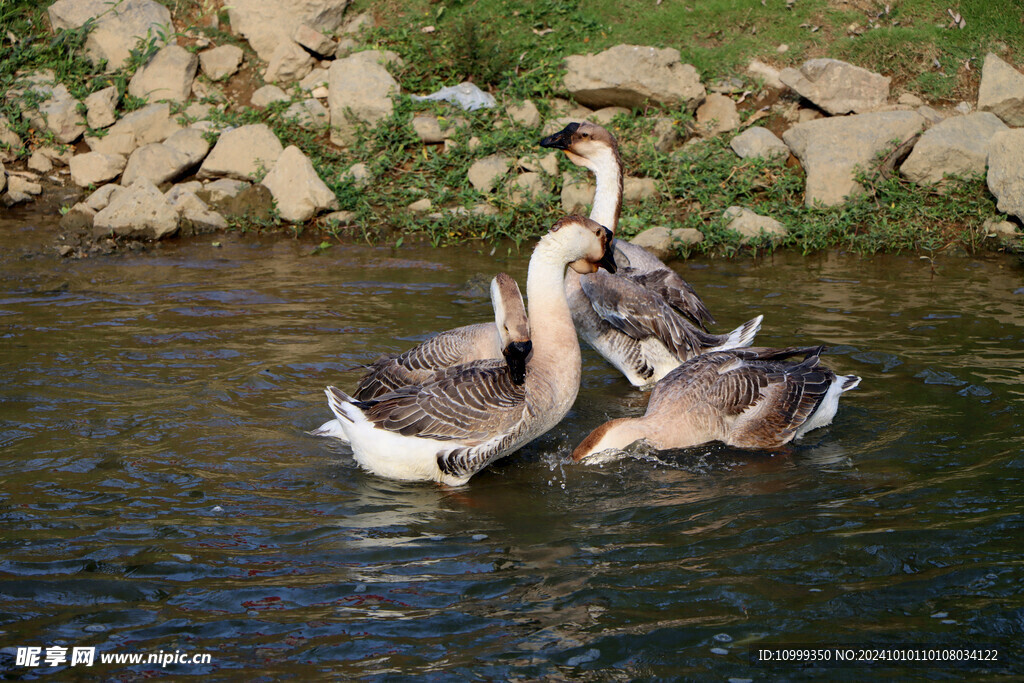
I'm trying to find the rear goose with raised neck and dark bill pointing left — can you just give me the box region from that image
[540,122,763,388]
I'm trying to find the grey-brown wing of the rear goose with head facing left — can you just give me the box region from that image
[580,271,717,359]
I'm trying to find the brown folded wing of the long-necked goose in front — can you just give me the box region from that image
[358,360,525,444]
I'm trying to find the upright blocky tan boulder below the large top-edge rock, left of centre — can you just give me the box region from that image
[328,52,400,146]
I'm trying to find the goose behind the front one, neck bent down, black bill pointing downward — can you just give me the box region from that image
[309,272,532,441]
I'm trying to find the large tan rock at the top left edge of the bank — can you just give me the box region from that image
[47,0,174,72]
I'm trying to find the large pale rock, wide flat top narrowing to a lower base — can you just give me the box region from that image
[782,112,925,206]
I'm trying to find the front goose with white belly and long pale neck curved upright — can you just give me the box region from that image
[326,216,615,486]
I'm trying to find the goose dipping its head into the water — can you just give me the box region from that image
[572,346,860,462]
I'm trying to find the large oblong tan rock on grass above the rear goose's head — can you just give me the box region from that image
[563,45,705,112]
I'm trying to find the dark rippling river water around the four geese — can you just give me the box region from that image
[0,221,1024,681]
